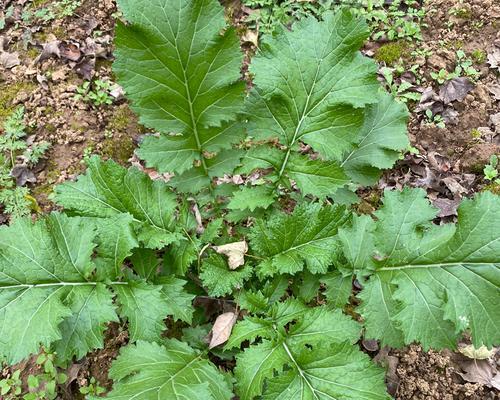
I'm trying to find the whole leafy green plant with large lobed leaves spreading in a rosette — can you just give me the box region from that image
[0,0,500,400]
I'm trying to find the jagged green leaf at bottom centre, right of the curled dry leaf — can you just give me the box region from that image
[226,299,388,400]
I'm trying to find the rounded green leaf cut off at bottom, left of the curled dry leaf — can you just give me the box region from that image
[107,339,233,400]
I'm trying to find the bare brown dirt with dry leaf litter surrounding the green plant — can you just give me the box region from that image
[0,0,500,400]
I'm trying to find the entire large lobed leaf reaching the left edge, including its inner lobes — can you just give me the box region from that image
[0,213,194,364]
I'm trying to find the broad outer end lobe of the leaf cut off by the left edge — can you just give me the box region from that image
[0,213,116,364]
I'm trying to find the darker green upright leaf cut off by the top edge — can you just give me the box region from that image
[114,0,245,182]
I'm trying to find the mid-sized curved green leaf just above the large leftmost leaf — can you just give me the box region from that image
[55,157,182,248]
